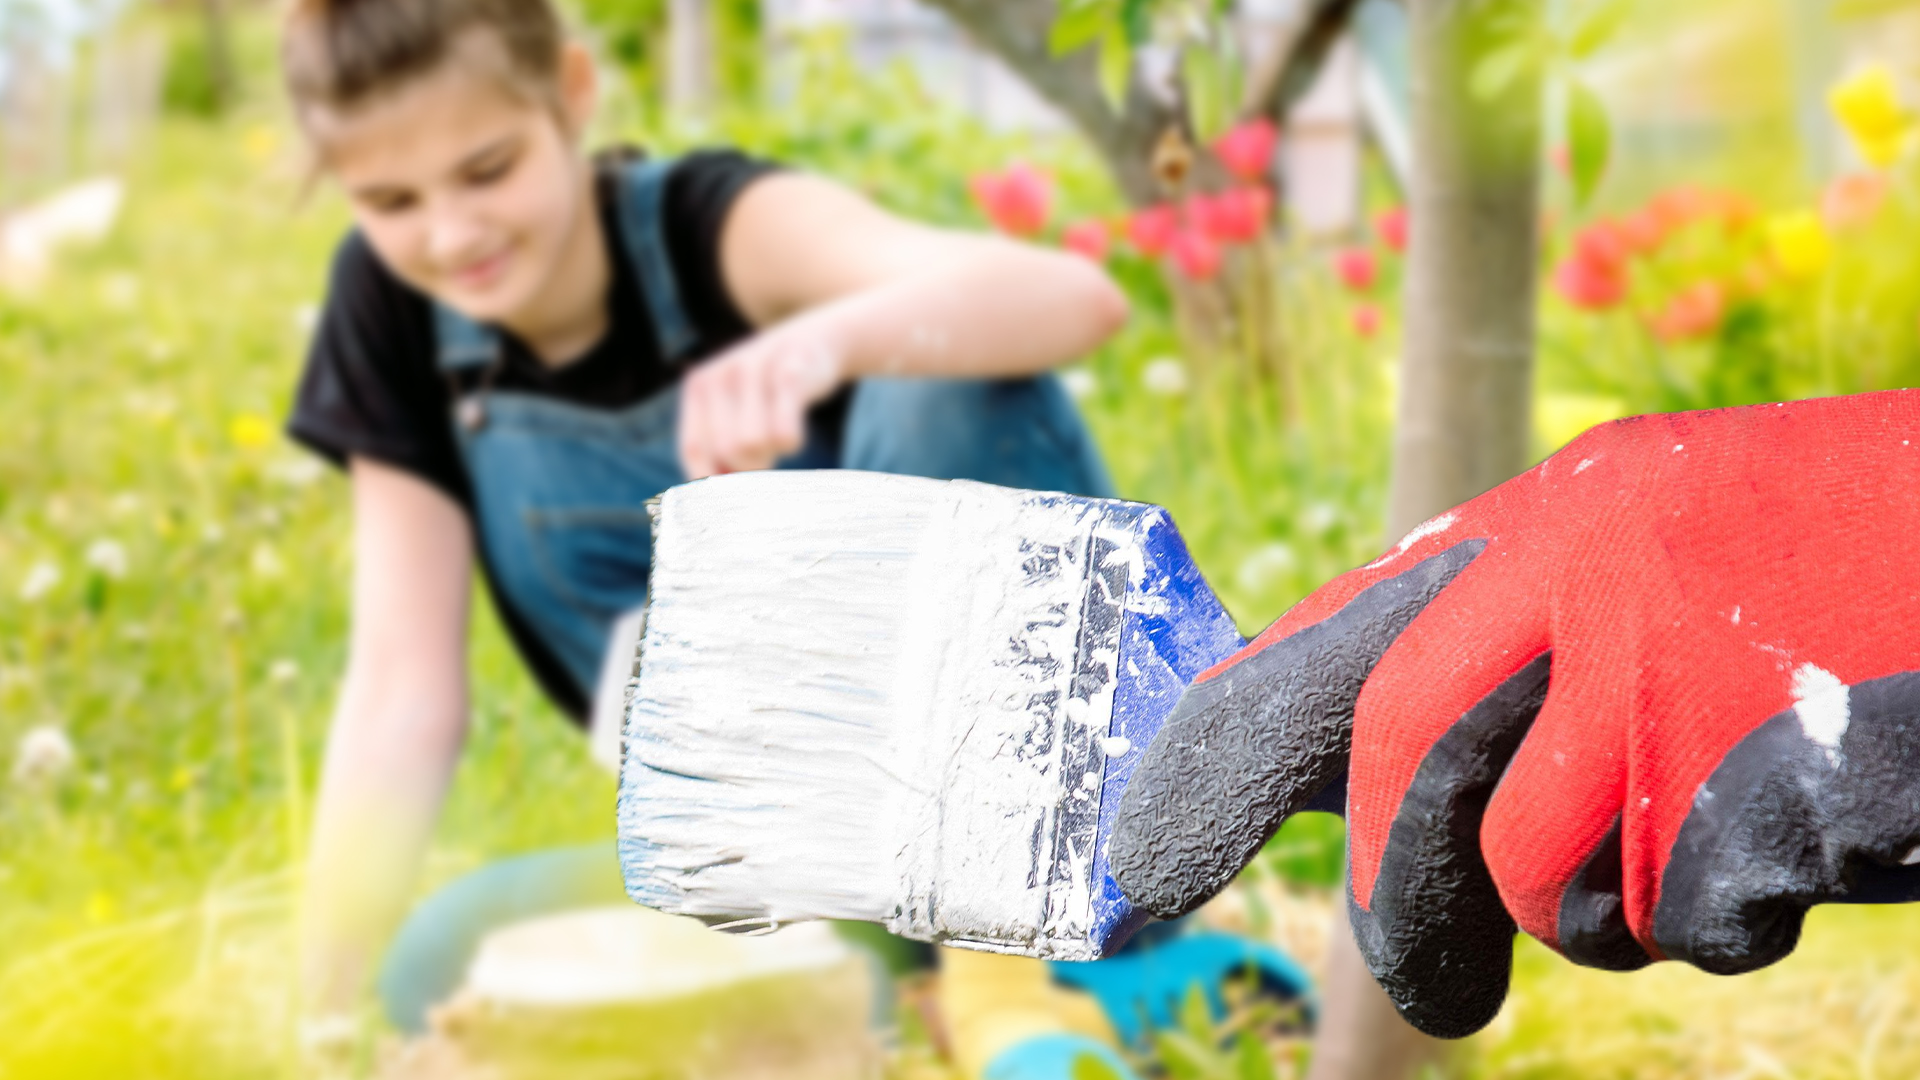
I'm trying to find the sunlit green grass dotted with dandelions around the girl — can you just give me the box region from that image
[11,23,1920,1080]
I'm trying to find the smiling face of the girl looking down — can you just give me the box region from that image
[307,42,595,327]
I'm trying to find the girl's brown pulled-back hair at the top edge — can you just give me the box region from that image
[280,0,564,111]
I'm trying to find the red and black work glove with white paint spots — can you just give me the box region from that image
[1112,392,1920,1036]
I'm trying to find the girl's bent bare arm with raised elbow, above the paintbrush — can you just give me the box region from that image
[680,173,1127,477]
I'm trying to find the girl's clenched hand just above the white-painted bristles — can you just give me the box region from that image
[680,319,847,480]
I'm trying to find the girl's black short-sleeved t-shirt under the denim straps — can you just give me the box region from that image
[288,150,776,719]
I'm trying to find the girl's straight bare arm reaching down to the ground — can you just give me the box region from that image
[301,457,472,1015]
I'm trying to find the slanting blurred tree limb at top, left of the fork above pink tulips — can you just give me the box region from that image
[924,0,1181,206]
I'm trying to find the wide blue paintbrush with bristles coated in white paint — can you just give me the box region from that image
[603,471,1244,959]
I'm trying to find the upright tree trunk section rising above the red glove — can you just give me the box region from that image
[1386,0,1540,536]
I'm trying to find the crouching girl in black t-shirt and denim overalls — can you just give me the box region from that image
[282,0,1297,1068]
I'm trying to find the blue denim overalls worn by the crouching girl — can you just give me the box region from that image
[380,153,1112,1032]
